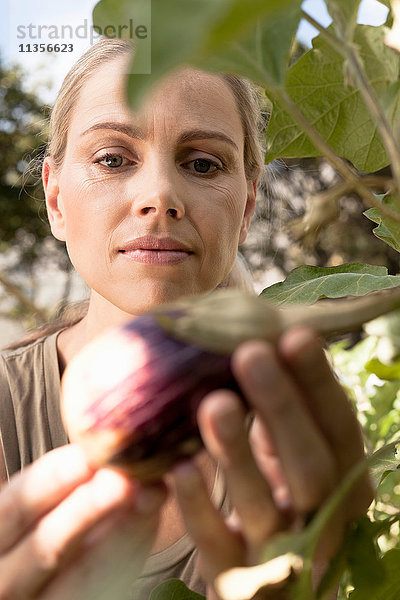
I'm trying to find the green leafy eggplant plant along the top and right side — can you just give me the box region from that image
[93,0,400,600]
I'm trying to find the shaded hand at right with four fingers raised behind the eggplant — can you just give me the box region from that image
[170,328,372,598]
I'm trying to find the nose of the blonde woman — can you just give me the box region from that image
[133,157,185,220]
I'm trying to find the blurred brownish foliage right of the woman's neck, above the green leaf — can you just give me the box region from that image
[241,158,400,291]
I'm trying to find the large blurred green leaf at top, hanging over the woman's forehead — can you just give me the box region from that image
[93,0,301,109]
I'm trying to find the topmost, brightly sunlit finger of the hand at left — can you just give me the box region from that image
[0,444,93,554]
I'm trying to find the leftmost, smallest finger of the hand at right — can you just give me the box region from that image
[171,462,245,583]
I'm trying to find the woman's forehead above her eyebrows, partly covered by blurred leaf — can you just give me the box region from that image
[70,58,243,144]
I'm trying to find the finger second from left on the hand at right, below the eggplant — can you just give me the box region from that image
[198,390,283,547]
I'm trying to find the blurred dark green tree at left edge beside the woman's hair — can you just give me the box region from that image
[0,56,70,325]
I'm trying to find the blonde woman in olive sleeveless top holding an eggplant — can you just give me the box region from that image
[0,40,371,600]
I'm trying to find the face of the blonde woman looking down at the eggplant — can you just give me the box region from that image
[43,58,255,314]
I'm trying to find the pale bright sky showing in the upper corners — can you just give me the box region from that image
[0,0,387,104]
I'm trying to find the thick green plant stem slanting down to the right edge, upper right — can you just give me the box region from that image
[301,10,400,194]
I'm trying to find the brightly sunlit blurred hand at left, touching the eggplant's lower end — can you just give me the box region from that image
[0,444,165,600]
